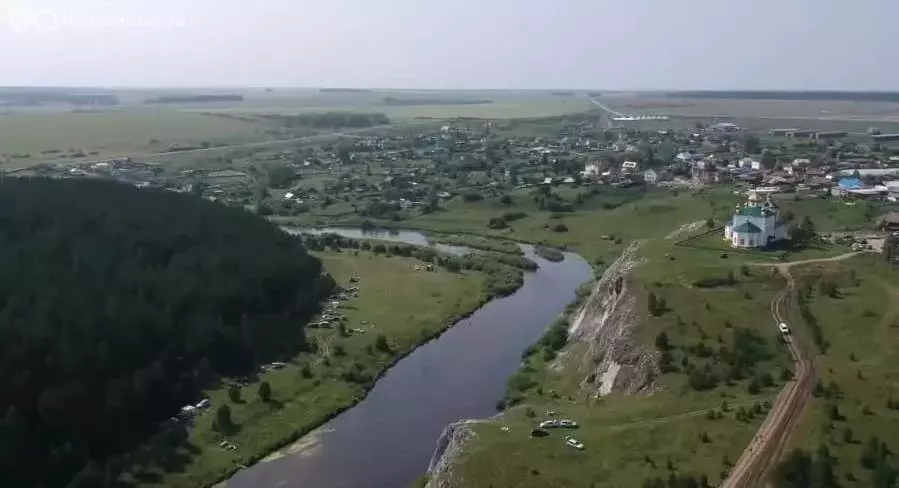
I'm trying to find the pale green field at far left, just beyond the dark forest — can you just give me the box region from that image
[0,109,265,162]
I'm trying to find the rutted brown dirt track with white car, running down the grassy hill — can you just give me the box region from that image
[720,253,860,488]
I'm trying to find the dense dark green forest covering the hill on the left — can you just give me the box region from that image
[0,178,333,488]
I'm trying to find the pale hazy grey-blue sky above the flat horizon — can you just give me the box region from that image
[0,0,899,91]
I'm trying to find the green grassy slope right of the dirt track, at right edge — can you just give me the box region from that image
[790,254,899,487]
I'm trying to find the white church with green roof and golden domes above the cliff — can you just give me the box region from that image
[724,190,787,248]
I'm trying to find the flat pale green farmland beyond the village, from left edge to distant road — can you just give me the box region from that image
[0,90,594,168]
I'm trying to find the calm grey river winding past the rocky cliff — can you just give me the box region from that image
[227,229,592,488]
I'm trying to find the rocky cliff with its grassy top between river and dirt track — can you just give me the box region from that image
[428,230,804,488]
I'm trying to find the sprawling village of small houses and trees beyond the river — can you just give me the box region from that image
[10,117,899,247]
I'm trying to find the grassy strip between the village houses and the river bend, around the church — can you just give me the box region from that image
[285,187,888,268]
